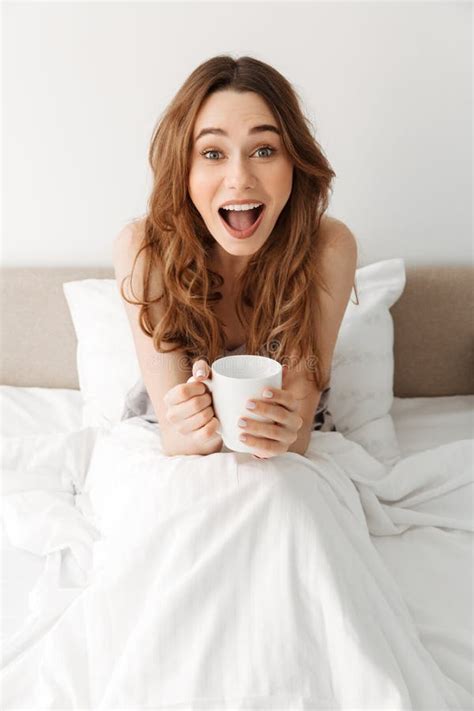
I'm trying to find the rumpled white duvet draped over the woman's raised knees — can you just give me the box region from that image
[2,420,474,711]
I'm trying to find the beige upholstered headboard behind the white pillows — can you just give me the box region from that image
[0,265,474,397]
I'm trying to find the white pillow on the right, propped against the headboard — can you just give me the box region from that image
[328,259,406,467]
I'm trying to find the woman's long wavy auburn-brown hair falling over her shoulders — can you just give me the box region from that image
[120,55,358,391]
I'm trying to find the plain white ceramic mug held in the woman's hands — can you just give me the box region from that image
[193,355,282,452]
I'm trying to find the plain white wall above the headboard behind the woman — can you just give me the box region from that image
[2,0,472,266]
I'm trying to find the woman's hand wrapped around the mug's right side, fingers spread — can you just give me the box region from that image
[239,376,303,459]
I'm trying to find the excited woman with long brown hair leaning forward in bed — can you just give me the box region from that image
[114,56,357,458]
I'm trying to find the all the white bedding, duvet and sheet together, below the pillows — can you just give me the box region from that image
[0,387,474,709]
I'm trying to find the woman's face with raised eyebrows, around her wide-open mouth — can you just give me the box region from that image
[188,90,293,273]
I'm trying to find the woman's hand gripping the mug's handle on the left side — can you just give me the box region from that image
[163,360,222,452]
